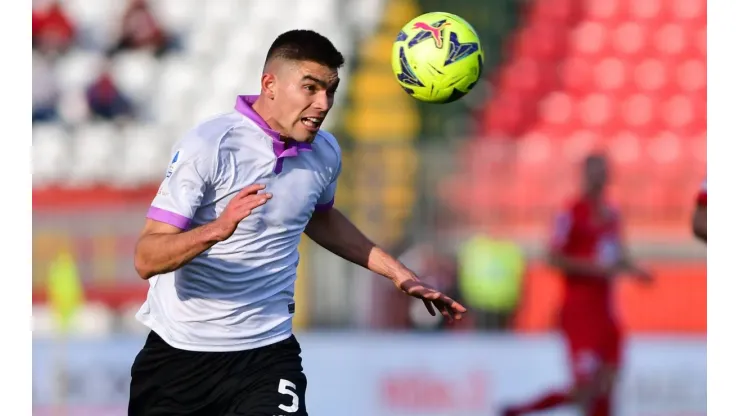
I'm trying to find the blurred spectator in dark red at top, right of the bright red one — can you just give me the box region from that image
[110,0,178,56]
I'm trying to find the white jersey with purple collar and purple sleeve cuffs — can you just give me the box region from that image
[137,96,341,351]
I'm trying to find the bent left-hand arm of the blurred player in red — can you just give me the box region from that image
[548,210,611,278]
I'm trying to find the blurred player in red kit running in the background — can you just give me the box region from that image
[504,154,652,416]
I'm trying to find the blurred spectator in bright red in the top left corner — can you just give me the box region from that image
[31,0,76,55]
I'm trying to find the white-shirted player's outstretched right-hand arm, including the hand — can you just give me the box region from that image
[305,162,466,319]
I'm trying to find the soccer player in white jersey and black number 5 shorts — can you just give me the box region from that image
[129,30,465,416]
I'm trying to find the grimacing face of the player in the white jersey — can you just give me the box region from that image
[274,61,339,142]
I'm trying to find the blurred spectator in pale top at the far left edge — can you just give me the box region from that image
[31,53,59,123]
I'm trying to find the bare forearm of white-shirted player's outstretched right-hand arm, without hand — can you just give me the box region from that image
[306,209,413,281]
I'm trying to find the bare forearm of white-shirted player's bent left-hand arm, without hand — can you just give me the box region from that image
[134,222,223,279]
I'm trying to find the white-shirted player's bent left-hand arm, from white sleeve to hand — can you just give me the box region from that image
[134,137,271,279]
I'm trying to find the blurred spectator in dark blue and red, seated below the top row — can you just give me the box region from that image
[86,61,134,120]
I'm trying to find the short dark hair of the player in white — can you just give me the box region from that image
[266,30,344,69]
